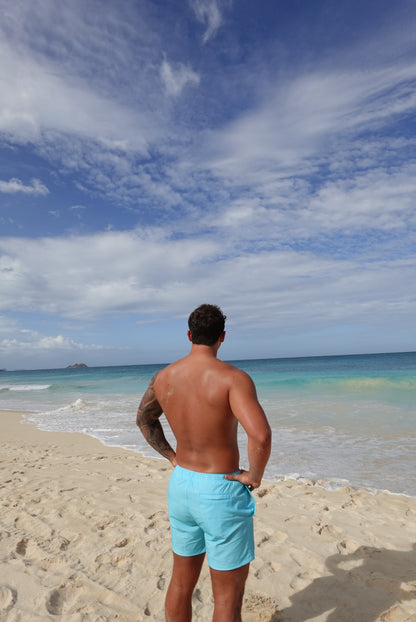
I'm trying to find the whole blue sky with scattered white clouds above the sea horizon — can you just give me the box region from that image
[0,0,416,369]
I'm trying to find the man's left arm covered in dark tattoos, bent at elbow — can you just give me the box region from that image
[136,374,176,466]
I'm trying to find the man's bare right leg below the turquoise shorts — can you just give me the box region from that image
[210,564,250,622]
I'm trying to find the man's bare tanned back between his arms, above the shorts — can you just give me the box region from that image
[154,346,264,473]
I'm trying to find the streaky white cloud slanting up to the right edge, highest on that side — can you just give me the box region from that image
[206,60,416,183]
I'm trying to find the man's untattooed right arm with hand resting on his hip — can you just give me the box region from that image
[226,372,272,489]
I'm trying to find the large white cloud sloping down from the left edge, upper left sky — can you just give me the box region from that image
[0,42,152,153]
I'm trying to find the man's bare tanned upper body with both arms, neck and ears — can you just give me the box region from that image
[137,332,270,488]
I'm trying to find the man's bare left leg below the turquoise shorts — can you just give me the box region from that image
[165,553,205,622]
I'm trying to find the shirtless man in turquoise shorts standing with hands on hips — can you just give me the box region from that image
[137,304,271,622]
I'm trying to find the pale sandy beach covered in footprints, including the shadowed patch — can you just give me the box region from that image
[0,412,416,622]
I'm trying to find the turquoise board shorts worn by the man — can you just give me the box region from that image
[168,466,256,570]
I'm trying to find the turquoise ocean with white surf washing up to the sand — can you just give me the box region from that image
[0,352,416,496]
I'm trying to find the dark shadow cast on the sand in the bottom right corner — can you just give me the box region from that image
[270,544,416,622]
